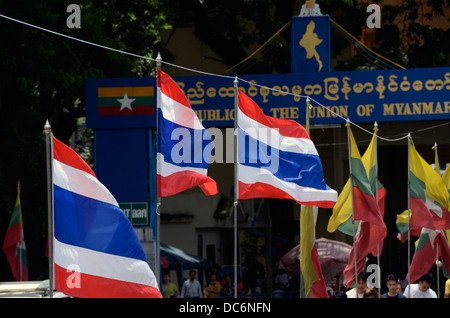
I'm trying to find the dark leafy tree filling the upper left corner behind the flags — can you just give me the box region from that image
[0,0,165,280]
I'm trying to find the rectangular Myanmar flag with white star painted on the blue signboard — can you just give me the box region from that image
[97,86,155,116]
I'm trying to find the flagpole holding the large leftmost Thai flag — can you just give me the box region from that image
[44,120,55,298]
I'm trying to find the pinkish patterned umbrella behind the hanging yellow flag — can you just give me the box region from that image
[278,238,352,279]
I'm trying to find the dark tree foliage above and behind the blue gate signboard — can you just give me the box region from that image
[161,0,450,74]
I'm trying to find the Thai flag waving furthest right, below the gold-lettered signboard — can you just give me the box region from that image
[238,91,337,208]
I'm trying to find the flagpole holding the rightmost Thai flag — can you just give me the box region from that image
[233,76,239,298]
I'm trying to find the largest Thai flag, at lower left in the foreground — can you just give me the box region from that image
[52,138,161,298]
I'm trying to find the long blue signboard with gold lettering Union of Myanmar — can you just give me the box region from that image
[86,67,450,128]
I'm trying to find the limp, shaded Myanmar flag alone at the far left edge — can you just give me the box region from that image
[3,181,28,281]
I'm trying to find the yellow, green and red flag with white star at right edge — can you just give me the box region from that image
[409,140,450,230]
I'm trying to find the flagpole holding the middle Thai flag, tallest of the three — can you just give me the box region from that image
[155,53,162,288]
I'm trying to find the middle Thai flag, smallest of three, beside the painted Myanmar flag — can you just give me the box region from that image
[157,70,218,197]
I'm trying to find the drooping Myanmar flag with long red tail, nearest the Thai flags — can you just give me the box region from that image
[343,127,387,287]
